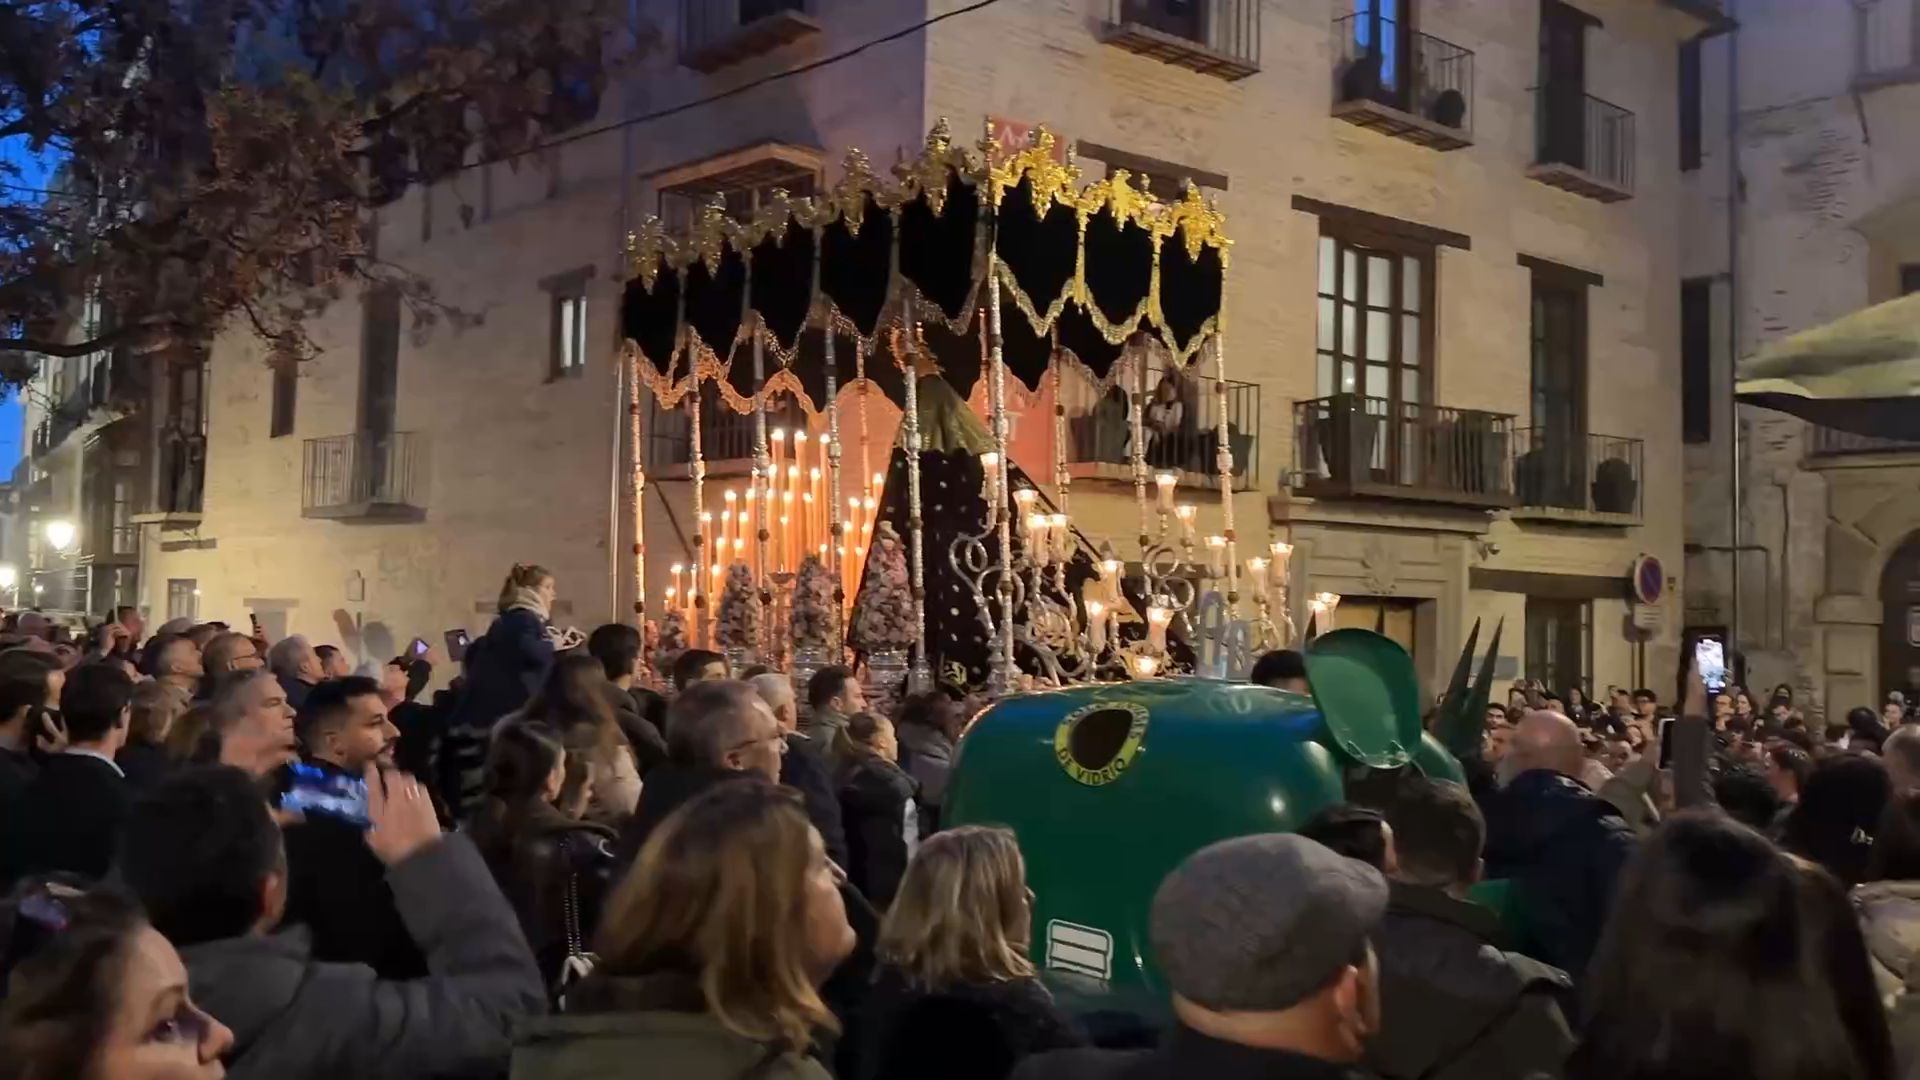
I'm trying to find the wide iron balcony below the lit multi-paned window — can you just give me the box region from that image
[1292,394,1513,509]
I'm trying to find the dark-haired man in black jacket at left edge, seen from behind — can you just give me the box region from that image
[0,663,132,882]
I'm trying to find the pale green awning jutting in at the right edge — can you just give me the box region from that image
[1734,294,1920,438]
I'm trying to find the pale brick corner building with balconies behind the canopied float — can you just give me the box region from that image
[144,0,1716,688]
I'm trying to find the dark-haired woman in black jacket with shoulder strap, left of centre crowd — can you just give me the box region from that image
[467,721,614,980]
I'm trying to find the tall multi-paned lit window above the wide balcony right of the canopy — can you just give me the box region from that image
[1317,228,1434,405]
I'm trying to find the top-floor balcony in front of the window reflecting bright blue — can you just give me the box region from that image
[1332,12,1473,150]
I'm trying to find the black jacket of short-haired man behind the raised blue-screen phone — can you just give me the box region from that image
[282,761,426,978]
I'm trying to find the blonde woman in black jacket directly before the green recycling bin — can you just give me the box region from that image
[851,824,1085,1080]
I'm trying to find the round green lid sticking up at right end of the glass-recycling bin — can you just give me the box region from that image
[1306,628,1423,769]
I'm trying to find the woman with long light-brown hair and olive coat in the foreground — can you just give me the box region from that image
[513,780,854,1080]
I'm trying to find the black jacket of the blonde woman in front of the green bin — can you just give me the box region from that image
[841,965,1087,1080]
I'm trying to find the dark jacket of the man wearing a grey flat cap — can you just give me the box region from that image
[1012,1024,1374,1080]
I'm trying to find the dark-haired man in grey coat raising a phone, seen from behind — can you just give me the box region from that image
[121,767,545,1080]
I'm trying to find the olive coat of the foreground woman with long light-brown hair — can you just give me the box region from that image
[513,972,829,1080]
